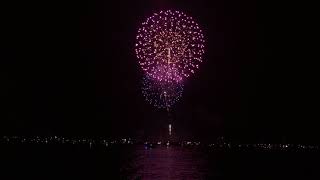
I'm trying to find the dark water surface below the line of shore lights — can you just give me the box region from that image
[0,144,320,180]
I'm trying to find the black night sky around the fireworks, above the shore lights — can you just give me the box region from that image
[0,0,319,142]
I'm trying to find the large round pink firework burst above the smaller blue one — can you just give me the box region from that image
[135,10,205,82]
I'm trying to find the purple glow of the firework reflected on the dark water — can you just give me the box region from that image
[126,147,208,180]
